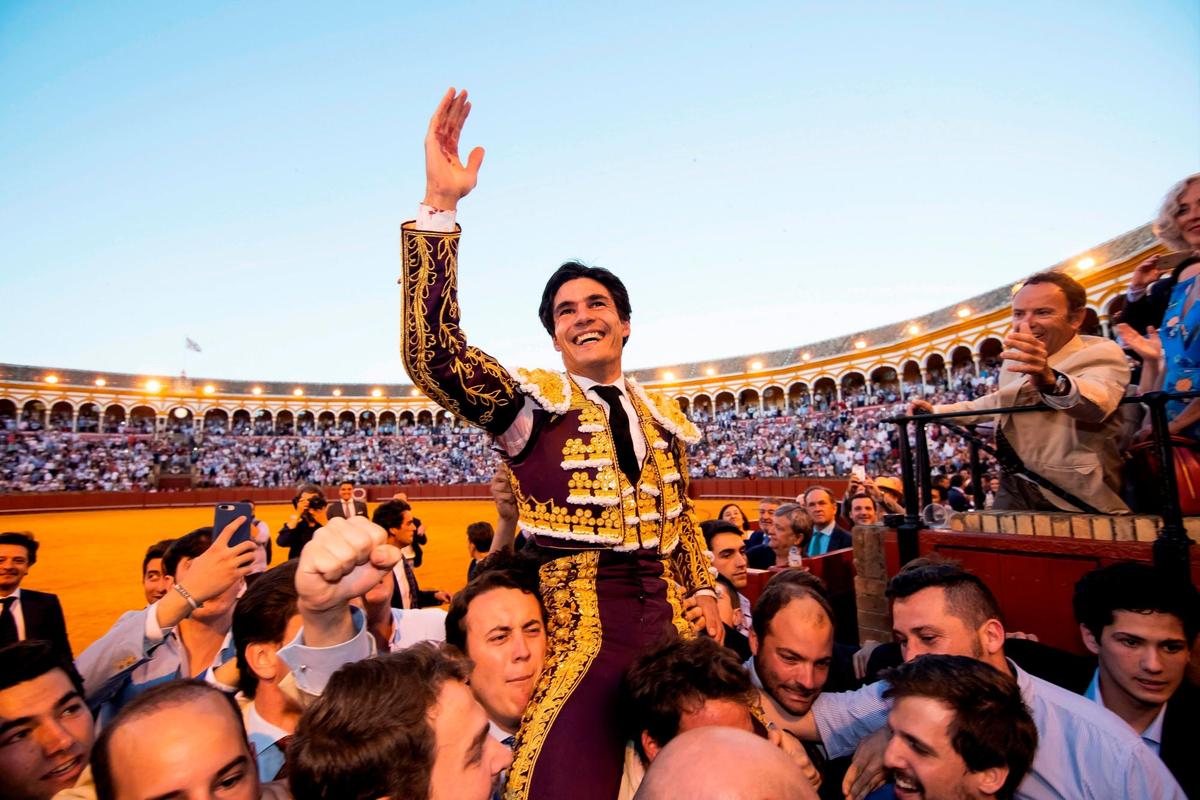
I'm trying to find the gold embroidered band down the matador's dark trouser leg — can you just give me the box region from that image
[504,551,602,800]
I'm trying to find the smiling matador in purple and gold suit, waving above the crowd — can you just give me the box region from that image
[401,89,722,800]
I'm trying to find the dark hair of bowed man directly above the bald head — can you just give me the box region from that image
[620,637,757,763]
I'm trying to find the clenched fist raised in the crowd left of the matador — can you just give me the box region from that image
[296,517,400,621]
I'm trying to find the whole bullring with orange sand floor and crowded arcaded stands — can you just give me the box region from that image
[0,219,1196,651]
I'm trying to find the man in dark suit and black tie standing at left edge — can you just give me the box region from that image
[0,533,73,660]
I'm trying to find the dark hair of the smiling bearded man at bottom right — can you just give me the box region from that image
[881,655,1038,798]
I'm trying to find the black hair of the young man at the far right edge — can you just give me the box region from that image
[1072,561,1200,646]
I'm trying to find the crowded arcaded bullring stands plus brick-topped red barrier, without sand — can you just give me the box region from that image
[0,217,1200,648]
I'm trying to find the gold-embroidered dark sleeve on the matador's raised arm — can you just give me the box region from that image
[401,228,516,426]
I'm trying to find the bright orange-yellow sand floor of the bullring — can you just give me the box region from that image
[9,500,757,654]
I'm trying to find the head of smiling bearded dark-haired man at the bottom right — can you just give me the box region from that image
[870,656,1038,800]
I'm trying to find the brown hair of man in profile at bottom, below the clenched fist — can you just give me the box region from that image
[288,642,470,800]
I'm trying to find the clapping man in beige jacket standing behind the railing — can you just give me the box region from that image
[910,272,1129,513]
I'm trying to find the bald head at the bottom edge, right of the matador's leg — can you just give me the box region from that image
[634,727,817,800]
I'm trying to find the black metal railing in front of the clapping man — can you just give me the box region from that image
[883,390,1200,581]
